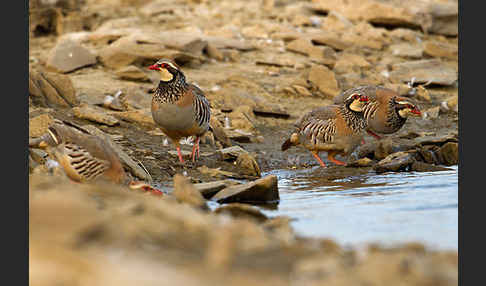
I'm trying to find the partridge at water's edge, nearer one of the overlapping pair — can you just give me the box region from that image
[282,91,368,167]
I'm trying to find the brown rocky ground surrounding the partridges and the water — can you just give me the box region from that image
[29,0,459,285]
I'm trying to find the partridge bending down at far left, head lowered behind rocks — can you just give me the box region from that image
[29,121,162,194]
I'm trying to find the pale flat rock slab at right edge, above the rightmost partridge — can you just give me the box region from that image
[390,59,457,85]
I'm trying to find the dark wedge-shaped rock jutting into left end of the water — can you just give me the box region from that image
[211,175,280,204]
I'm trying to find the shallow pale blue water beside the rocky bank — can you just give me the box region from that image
[263,166,458,250]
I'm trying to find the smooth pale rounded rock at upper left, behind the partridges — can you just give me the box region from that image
[47,38,96,73]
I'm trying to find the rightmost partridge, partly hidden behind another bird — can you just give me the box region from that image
[334,85,421,139]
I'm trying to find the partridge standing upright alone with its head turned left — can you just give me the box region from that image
[149,59,211,163]
